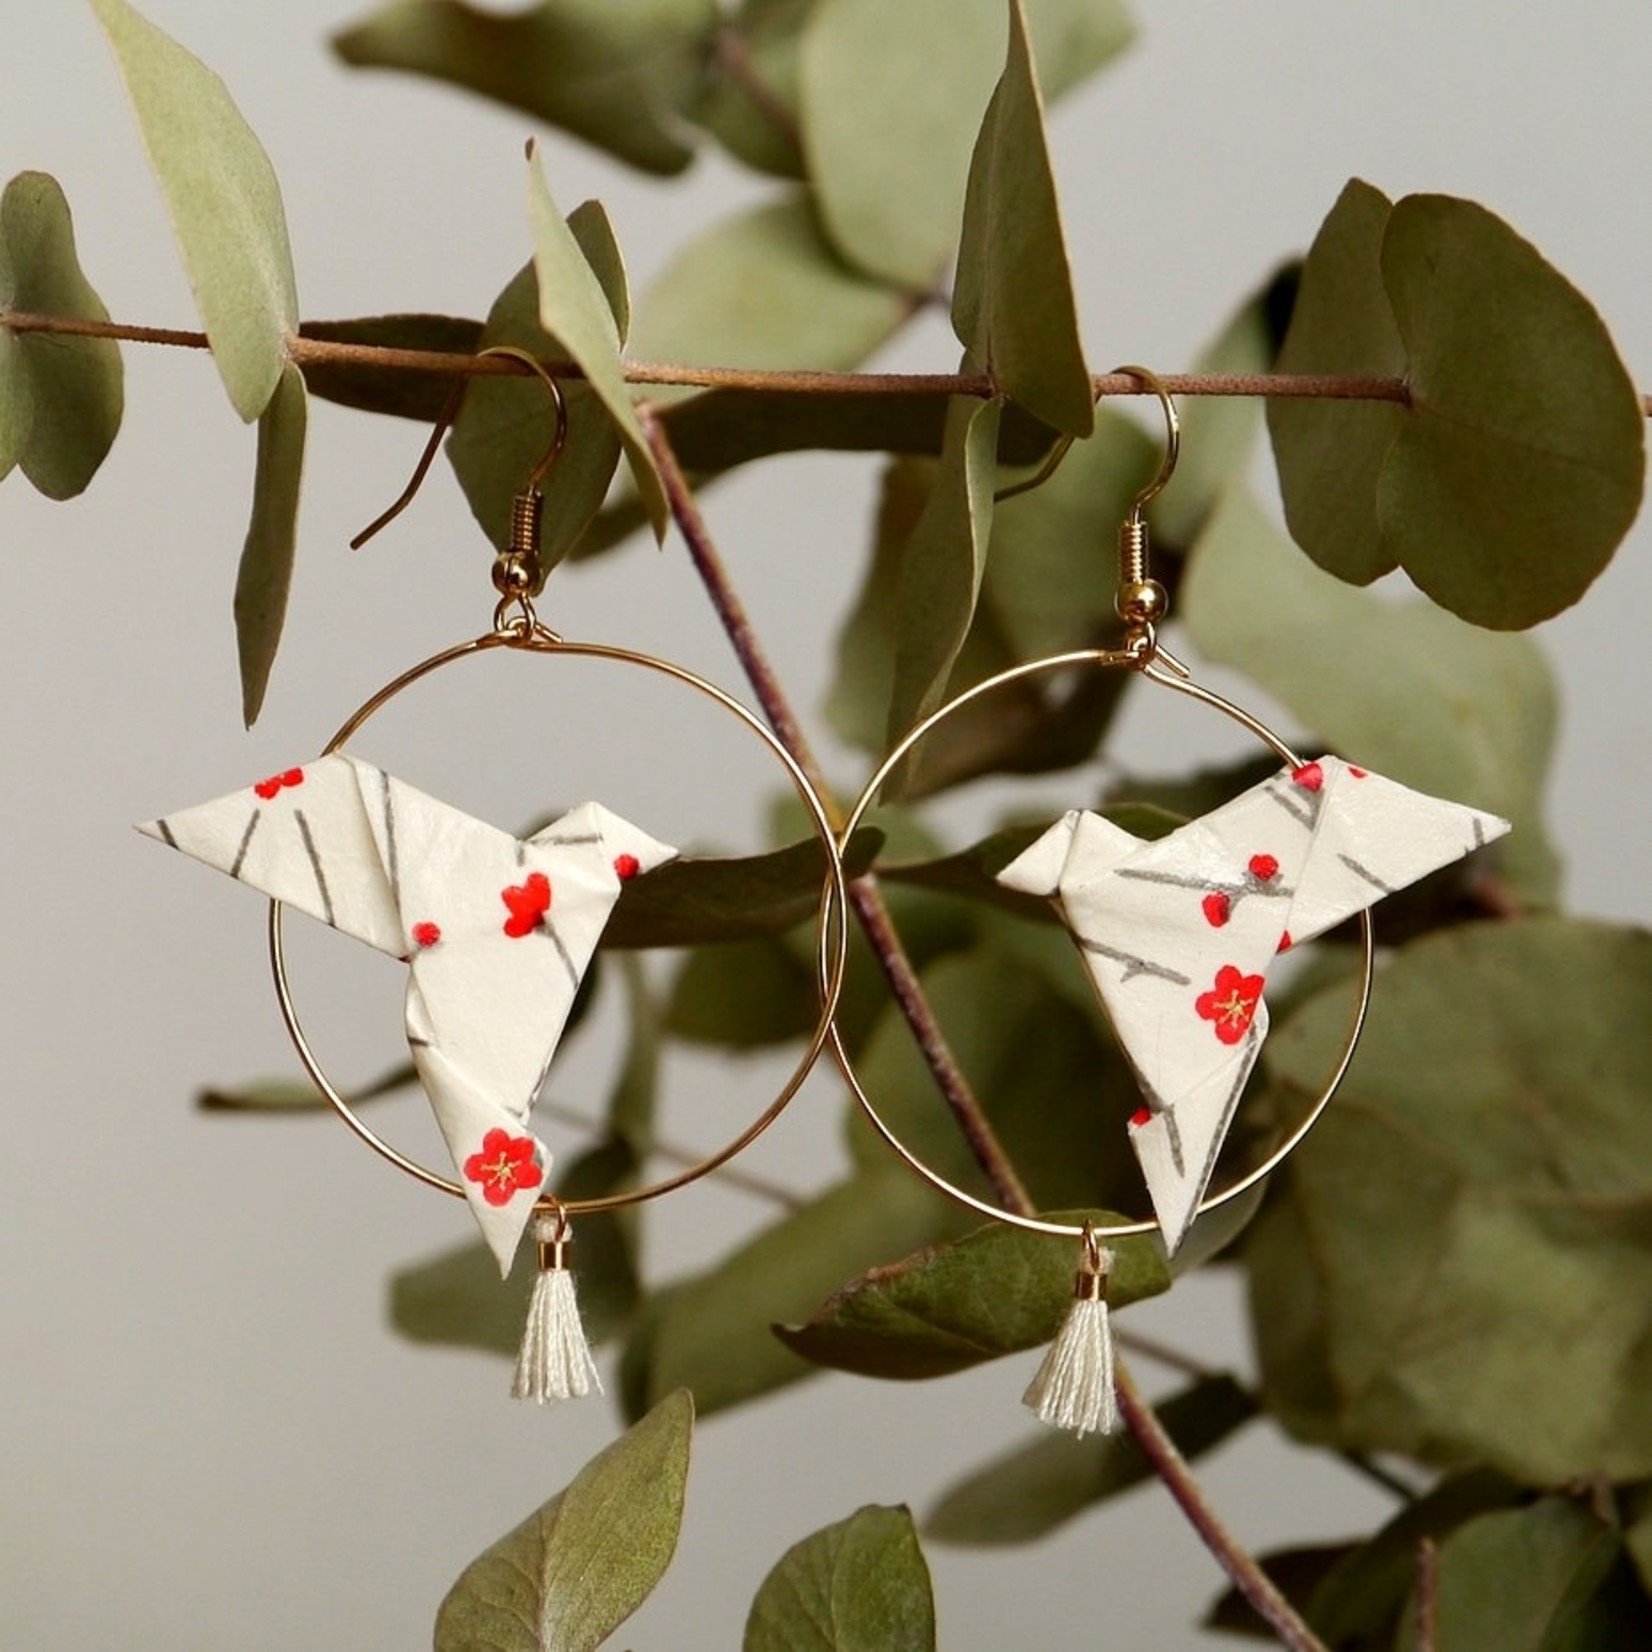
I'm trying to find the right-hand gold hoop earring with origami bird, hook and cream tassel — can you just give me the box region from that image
[821,367,1508,1434]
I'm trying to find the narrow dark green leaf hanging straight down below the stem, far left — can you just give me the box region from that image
[235,362,309,729]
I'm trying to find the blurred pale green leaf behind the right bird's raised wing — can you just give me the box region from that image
[1181,492,1559,902]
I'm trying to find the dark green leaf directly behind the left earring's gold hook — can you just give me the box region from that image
[448,202,629,573]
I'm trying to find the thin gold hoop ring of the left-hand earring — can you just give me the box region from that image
[269,624,849,1218]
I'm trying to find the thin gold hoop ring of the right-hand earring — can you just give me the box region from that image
[819,647,1376,1244]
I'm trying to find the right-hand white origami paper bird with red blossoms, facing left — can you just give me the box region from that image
[998,757,1508,1252]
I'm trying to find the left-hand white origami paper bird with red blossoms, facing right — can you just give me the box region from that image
[139,753,676,1274]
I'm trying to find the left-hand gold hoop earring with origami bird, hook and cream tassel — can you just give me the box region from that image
[140,347,847,1401]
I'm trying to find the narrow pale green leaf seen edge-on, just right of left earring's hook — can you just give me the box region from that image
[527,154,671,539]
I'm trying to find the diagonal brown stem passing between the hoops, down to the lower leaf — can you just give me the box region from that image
[638,403,1034,1216]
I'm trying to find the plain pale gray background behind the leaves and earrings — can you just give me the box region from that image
[0,0,1652,1652]
